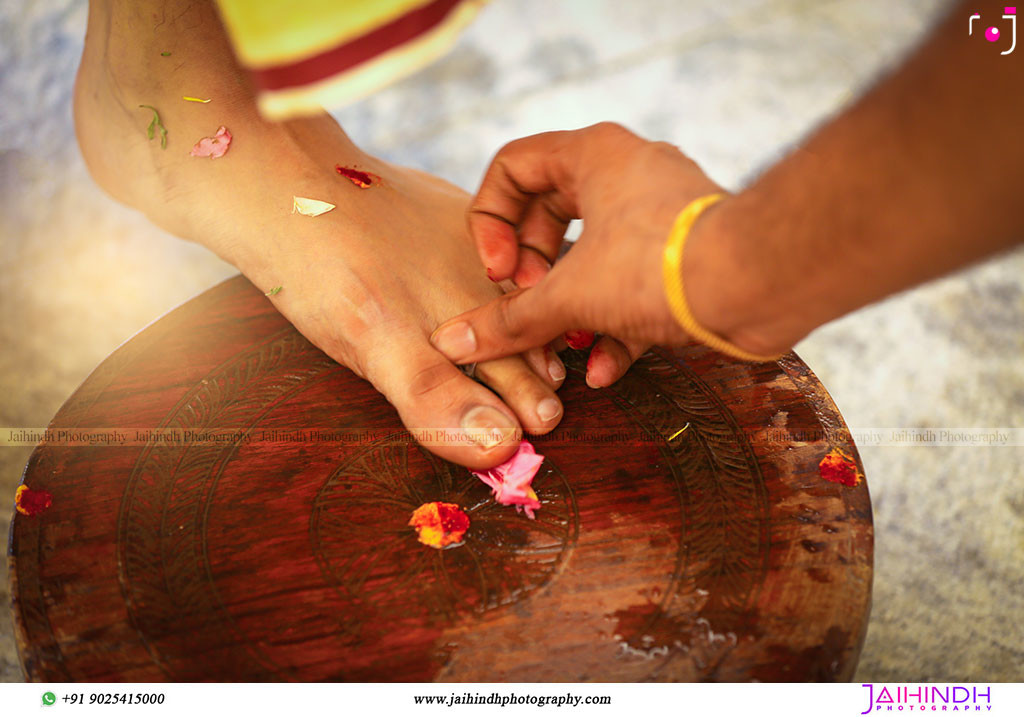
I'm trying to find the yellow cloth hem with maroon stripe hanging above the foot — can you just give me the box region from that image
[217,0,485,120]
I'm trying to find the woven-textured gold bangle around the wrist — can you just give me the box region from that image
[662,193,778,362]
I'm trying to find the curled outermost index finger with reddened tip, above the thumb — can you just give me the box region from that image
[468,132,580,280]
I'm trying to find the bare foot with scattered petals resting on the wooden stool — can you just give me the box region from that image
[75,0,565,467]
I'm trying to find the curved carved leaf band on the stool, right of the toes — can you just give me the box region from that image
[593,351,771,679]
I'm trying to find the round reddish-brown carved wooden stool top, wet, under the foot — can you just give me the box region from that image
[8,278,872,681]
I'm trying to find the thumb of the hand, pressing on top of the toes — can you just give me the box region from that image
[430,271,571,364]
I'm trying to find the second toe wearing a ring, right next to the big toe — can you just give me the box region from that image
[476,356,562,434]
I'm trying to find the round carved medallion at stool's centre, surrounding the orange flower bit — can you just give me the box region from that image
[309,435,580,631]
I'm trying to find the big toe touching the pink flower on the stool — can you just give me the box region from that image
[361,328,522,468]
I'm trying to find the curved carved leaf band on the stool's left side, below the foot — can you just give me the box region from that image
[118,329,331,679]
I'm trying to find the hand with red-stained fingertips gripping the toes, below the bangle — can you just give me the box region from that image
[432,124,774,374]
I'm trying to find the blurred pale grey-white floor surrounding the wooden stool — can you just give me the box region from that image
[0,0,1024,682]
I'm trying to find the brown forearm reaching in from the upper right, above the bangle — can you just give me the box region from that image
[686,0,1024,348]
